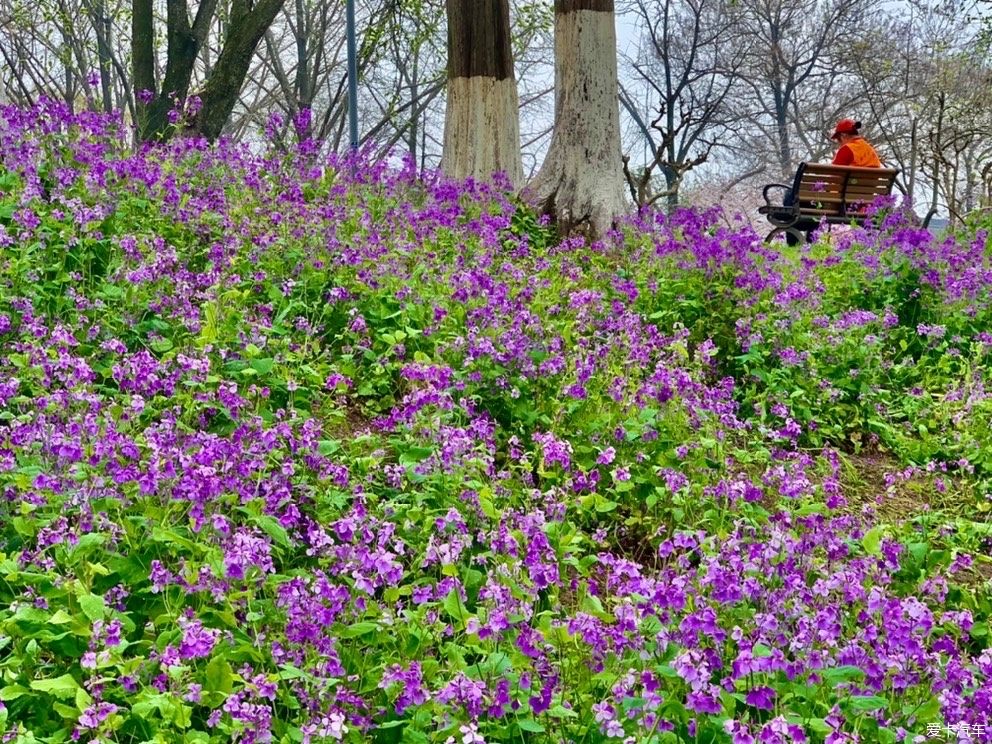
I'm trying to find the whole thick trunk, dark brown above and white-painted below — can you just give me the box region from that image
[441,0,523,187]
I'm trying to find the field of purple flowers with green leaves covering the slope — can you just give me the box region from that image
[0,104,992,744]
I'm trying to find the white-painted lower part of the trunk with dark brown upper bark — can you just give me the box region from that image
[441,76,524,189]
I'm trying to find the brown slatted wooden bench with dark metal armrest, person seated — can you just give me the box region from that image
[758,163,899,245]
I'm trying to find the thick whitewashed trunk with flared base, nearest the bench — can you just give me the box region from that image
[527,0,627,238]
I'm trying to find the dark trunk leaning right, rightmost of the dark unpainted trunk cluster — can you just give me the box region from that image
[192,0,285,140]
